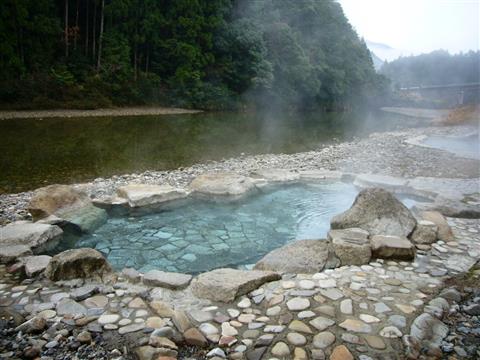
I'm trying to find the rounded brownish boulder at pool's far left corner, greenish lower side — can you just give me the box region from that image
[28,185,107,232]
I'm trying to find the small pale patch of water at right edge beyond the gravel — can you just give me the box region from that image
[423,134,480,159]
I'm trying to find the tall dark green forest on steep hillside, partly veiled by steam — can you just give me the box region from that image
[0,0,386,109]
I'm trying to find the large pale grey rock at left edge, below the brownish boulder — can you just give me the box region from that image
[0,221,63,262]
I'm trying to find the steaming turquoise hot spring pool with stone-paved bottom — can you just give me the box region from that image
[56,182,426,273]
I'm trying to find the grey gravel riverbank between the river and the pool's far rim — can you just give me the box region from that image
[0,126,480,224]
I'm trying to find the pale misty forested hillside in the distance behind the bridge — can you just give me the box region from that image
[380,50,480,88]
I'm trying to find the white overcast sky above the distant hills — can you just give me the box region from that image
[338,0,480,55]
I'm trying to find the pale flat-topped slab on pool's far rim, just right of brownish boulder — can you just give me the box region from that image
[117,184,187,207]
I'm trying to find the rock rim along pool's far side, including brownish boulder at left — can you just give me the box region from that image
[0,169,480,263]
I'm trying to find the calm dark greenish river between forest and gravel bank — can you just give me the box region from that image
[0,112,428,193]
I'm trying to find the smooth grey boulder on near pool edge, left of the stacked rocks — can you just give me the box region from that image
[255,240,338,274]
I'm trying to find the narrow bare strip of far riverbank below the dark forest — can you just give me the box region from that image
[0,107,202,120]
